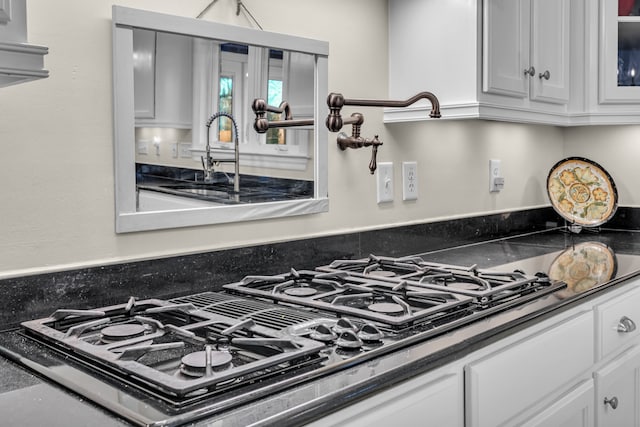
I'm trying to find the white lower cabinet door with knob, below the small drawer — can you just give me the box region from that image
[594,346,640,427]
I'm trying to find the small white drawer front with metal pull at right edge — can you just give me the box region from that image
[595,287,640,359]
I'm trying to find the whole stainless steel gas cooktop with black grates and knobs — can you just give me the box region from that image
[0,255,565,425]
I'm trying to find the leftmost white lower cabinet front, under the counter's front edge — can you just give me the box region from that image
[307,368,464,427]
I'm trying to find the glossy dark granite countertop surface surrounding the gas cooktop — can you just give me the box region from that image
[0,229,640,427]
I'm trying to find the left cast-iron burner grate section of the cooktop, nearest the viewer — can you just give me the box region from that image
[17,296,325,407]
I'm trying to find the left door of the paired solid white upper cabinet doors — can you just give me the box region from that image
[482,0,532,98]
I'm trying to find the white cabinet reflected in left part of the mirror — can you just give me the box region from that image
[134,30,193,129]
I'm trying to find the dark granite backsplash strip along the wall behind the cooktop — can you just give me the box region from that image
[0,207,624,328]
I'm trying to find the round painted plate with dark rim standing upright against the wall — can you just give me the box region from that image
[547,157,618,227]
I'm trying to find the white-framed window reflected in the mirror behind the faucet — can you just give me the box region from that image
[192,40,315,170]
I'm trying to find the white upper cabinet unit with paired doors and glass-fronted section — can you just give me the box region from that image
[385,0,640,126]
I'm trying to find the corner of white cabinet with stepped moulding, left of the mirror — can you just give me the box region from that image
[0,0,49,87]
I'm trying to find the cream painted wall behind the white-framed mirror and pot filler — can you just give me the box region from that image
[0,0,568,277]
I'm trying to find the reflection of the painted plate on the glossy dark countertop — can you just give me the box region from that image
[549,242,618,294]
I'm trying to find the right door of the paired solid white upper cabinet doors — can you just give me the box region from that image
[529,0,571,104]
